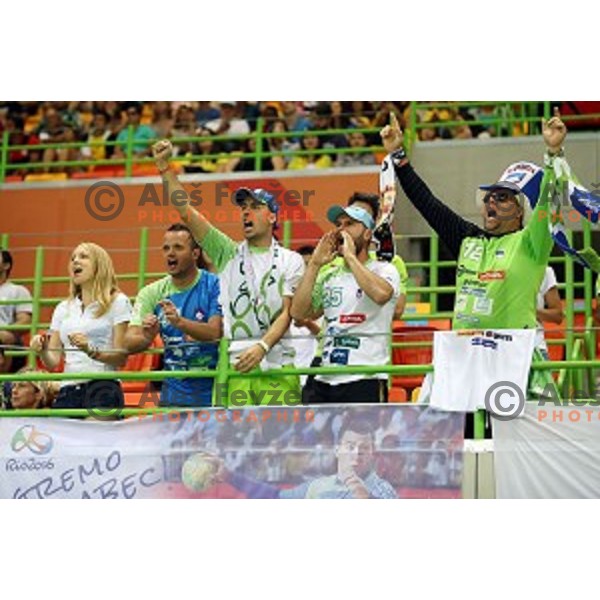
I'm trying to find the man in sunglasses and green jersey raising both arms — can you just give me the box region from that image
[381,112,567,329]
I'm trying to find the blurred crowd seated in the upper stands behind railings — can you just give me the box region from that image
[0,100,516,177]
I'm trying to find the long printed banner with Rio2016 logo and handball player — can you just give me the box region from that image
[0,404,464,499]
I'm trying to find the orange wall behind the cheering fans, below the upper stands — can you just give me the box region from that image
[0,173,378,324]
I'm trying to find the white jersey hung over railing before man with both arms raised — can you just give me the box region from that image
[430,329,535,412]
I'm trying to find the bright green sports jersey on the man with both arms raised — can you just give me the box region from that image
[453,169,553,329]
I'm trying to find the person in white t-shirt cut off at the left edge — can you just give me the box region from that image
[0,249,33,373]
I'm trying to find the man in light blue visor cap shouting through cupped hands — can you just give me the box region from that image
[291,194,400,404]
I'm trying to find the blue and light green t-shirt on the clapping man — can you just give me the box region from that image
[131,271,222,406]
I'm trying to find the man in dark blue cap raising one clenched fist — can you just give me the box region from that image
[152,140,304,406]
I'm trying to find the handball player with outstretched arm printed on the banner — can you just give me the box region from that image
[205,418,397,500]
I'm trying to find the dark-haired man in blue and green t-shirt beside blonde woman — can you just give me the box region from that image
[125,223,223,406]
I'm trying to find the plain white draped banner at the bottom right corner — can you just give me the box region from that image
[493,402,600,498]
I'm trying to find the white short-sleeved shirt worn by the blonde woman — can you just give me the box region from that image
[50,293,131,387]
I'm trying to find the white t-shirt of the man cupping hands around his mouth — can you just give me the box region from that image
[312,260,400,385]
